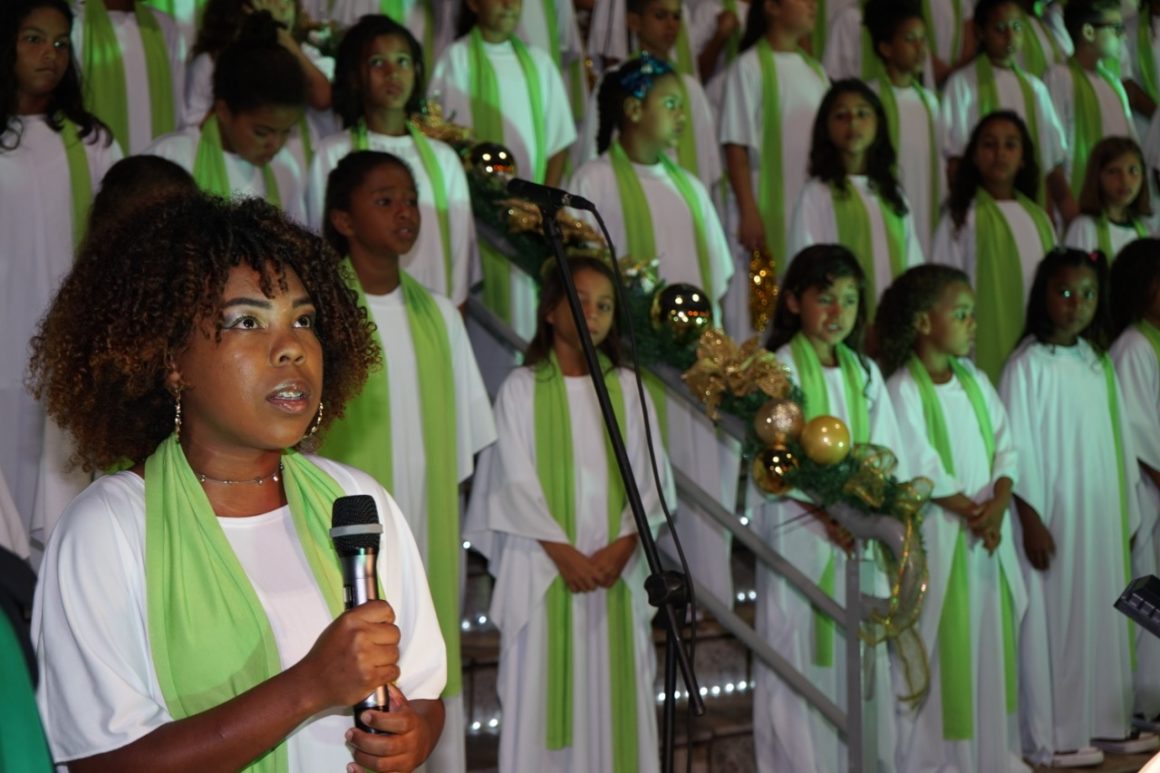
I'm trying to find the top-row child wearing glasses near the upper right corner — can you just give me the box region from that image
[1044,0,1136,197]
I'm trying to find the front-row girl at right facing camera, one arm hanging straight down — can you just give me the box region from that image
[999,247,1157,767]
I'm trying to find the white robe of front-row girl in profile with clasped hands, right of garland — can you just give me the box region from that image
[886,360,1028,773]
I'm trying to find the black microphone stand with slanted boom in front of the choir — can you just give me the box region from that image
[537,202,705,773]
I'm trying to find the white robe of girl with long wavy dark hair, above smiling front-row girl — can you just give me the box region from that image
[788,175,926,305]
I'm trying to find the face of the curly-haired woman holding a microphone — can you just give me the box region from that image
[169,266,322,455]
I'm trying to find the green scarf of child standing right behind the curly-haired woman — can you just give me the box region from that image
[322,259,463,695]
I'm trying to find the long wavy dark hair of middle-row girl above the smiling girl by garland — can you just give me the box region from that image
[810,78,908,215]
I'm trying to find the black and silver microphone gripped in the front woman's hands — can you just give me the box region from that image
[331,494,390,735]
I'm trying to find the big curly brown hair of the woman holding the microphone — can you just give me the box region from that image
[29,193,382,470]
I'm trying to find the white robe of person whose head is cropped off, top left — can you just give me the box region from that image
[72,0,186,156]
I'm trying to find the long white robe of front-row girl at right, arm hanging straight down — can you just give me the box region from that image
[999,339,1140,764]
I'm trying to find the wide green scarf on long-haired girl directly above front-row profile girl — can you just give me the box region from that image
[974,188,1056,384]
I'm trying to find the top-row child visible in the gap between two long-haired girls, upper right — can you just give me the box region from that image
[865,0,944,255]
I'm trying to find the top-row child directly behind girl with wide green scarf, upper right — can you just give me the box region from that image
[942,0,1079,223]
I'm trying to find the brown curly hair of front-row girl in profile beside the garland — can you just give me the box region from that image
[875,263,971,377]
